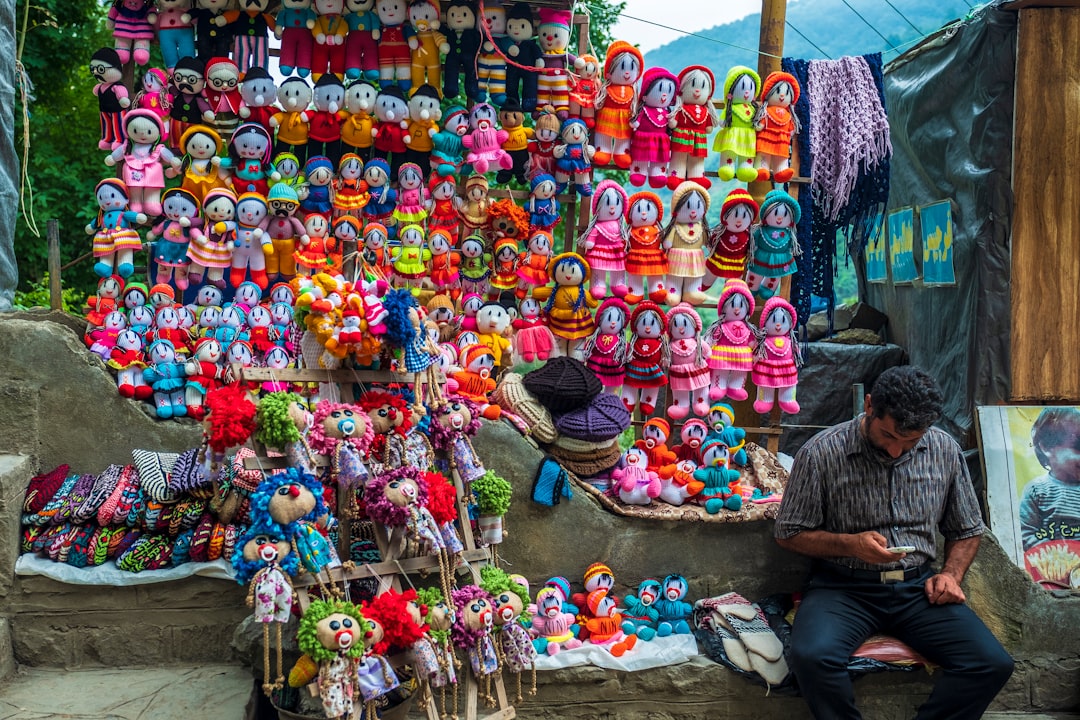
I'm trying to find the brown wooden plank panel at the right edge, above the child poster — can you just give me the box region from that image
[1011,8,1080,402]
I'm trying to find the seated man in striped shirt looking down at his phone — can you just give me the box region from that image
[774,366,1013,720]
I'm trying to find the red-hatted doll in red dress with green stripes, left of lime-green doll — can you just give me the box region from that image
[667,65,719,190]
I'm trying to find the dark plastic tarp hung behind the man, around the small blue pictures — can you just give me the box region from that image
[860,8,1016,447]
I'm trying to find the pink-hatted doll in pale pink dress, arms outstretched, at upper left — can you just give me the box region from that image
[105,109,180,217]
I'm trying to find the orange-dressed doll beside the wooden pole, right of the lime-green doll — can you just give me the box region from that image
[754,72,799,184]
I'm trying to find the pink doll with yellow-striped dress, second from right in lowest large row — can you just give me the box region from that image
[705,277,757,402]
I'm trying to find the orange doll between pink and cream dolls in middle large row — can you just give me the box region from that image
[623,191,667,305]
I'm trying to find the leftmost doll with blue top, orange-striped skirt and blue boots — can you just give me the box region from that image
[86,177,147,280]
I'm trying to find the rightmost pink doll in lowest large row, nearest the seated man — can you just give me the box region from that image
[750,297,802,415]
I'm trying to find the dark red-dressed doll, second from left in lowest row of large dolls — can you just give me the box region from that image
[622,300,669,416]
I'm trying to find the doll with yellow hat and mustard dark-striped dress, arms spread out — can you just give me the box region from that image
[532,253,599,361]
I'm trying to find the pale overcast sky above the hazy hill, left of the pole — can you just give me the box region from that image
[612,0,761,53]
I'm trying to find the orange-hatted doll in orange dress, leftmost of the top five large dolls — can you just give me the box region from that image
[593,40,645,169]
